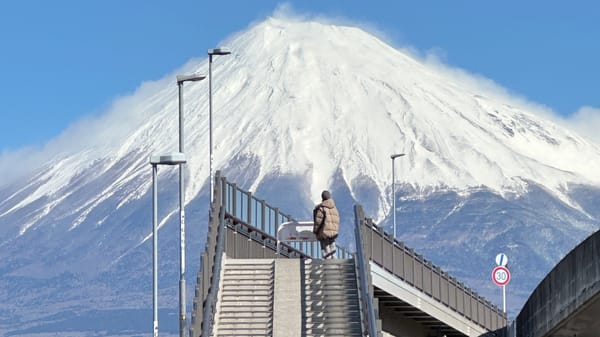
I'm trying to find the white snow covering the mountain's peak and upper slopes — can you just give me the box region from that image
[0,18,600,234]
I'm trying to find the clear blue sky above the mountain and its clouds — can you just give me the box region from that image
[0,0,600,155]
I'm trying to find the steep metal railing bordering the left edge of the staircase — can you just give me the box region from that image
[201,206,225,336]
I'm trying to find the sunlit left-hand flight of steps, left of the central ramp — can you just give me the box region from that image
[213,259,275,337]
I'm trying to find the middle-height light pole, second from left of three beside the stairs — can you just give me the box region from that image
[177,74,206,337]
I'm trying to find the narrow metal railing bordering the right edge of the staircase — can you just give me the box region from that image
[354,205,378,337]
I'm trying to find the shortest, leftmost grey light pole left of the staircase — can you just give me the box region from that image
[150,152,185,337]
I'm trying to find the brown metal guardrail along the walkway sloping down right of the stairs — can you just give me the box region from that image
[359,206,506,331]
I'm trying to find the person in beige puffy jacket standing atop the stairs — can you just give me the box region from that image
[313,191,340,259]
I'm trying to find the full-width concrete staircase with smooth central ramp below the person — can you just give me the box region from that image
[212,259,363,337]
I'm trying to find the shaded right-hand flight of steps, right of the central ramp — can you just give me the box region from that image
[303,259,363,337]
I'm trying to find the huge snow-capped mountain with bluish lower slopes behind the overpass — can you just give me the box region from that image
[0,18,600,335]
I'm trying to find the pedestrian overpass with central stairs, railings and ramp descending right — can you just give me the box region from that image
[190,173,506,337]
